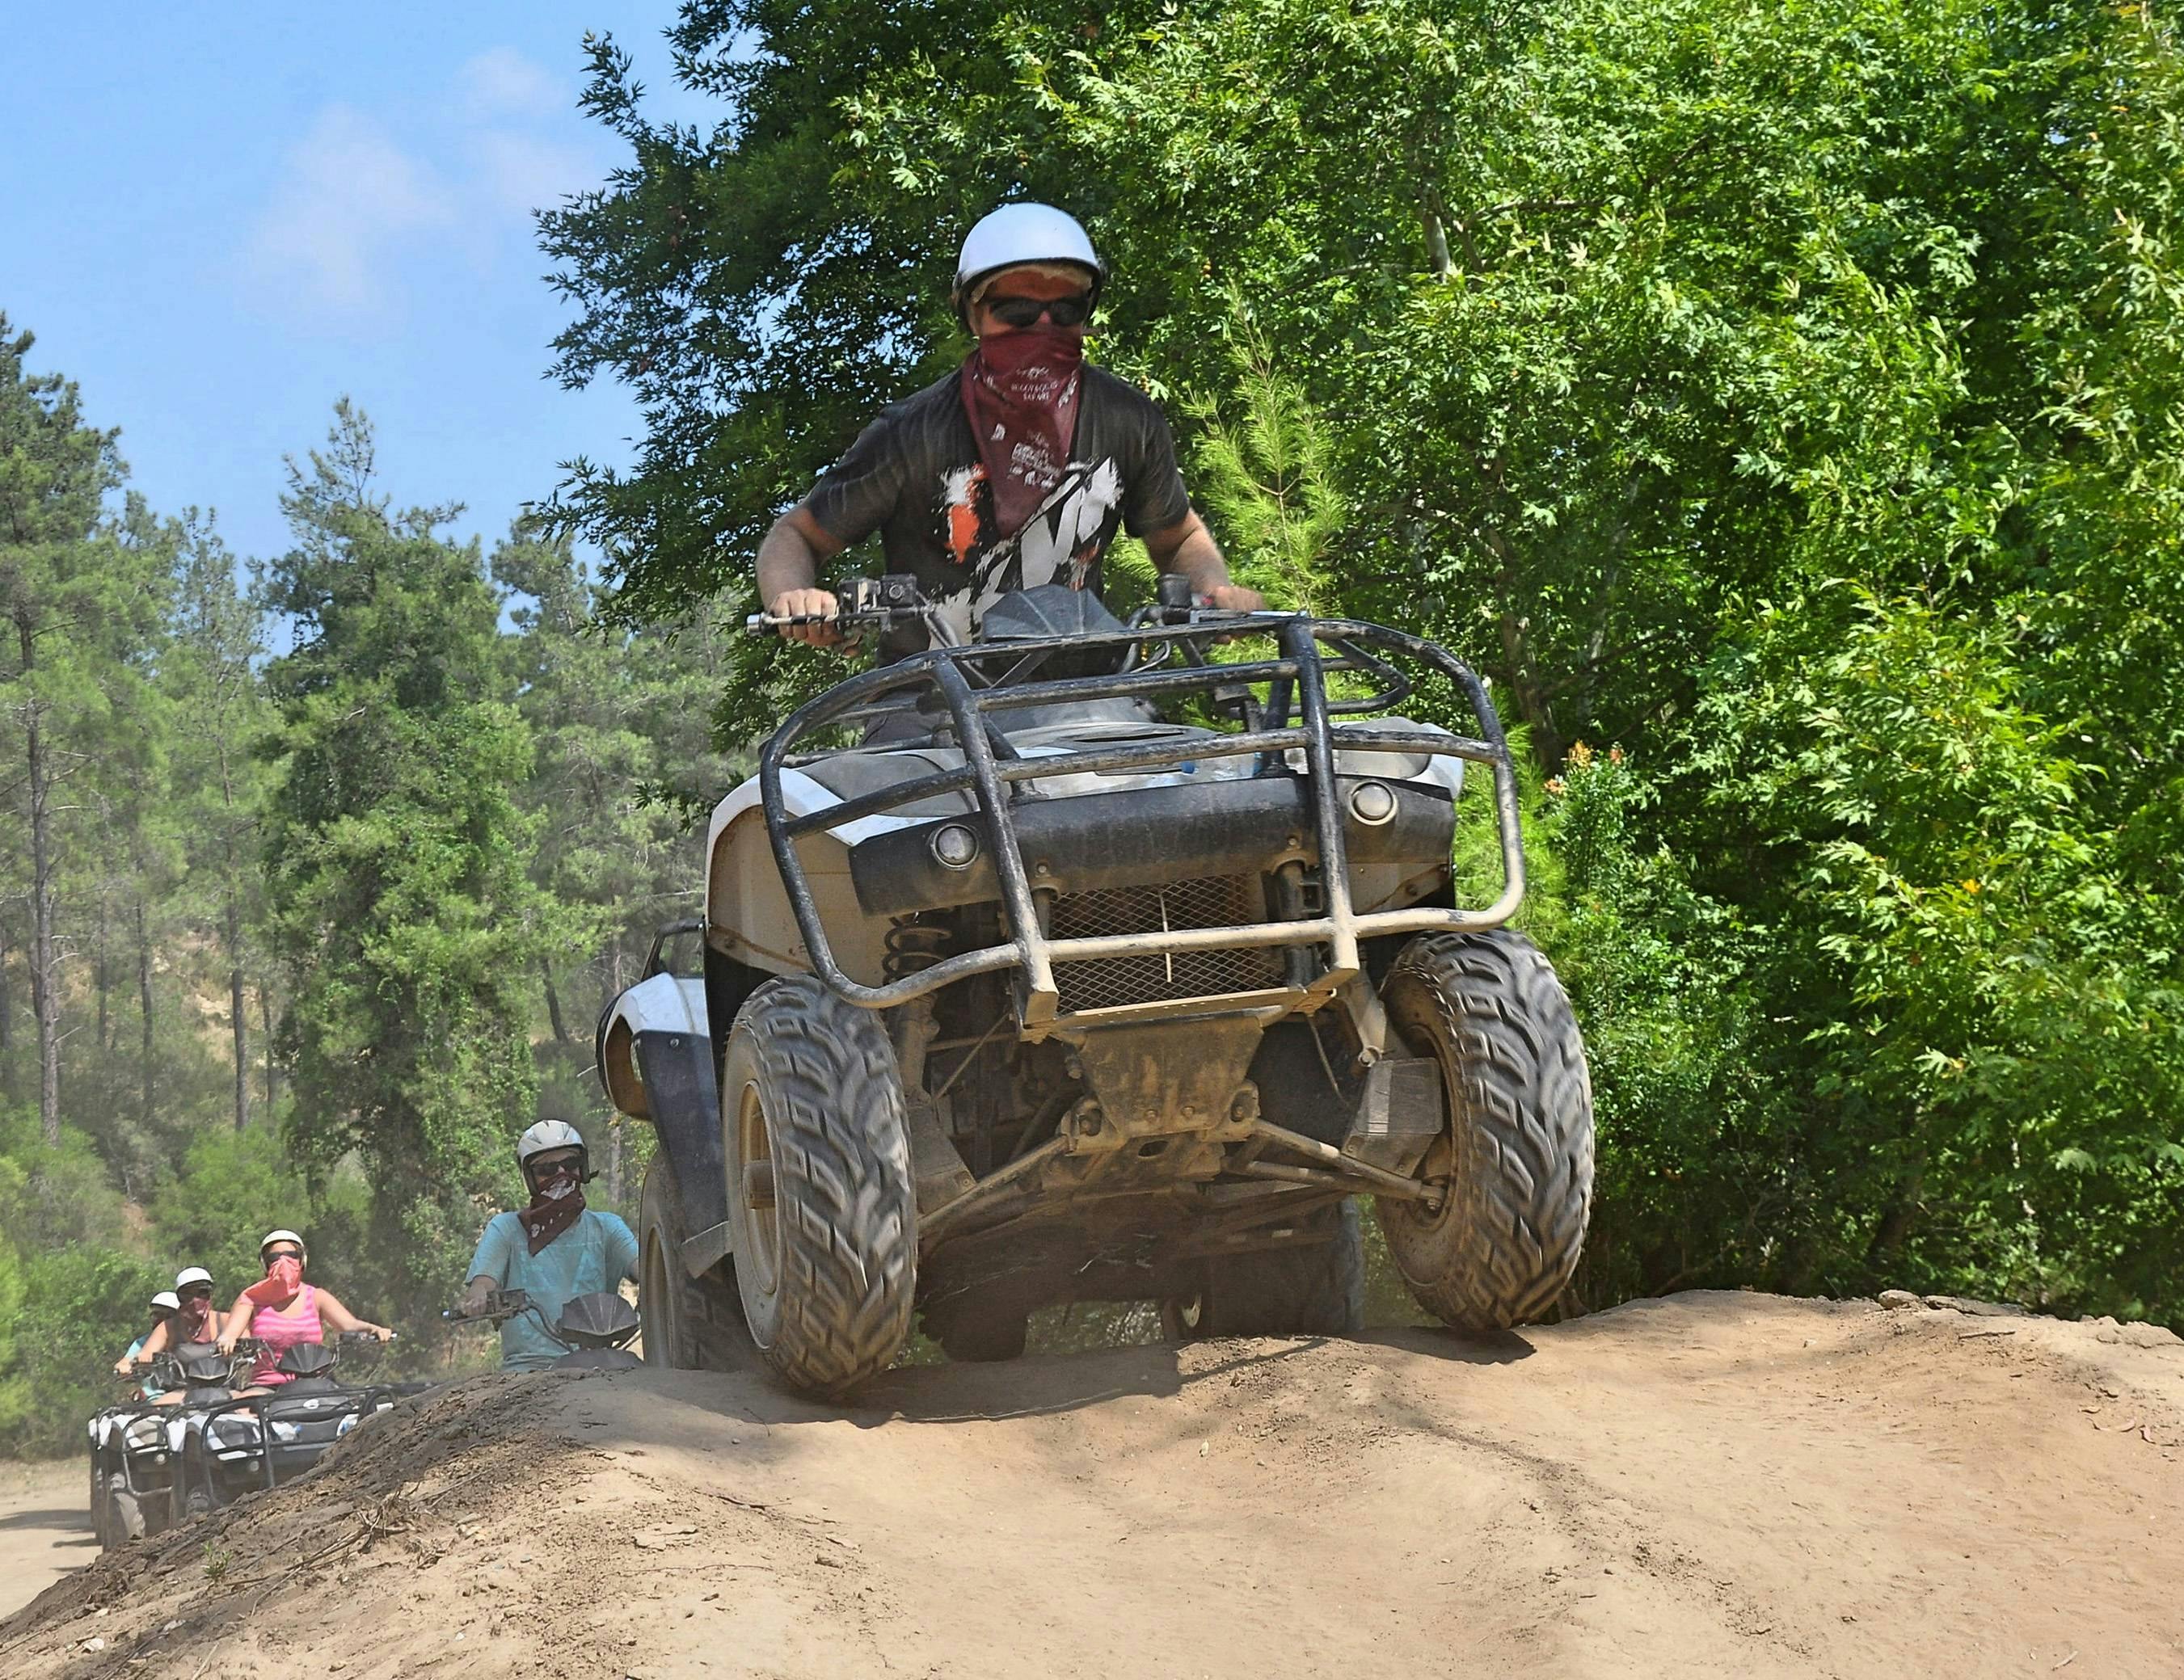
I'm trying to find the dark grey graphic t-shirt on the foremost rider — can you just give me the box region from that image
[806,364,1191,658]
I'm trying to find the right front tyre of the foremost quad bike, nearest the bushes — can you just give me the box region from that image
[1376,931,1592,1333]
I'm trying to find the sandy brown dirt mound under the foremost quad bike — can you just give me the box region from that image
[0,1295,2184,1680]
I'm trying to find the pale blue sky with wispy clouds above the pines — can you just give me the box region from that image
[0,0,719,576]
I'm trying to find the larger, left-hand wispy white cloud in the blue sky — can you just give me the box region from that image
[245,105,457,314]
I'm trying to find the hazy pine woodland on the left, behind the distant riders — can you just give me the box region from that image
[0,345,734,1453]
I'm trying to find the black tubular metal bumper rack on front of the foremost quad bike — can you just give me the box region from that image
[758,614,1524,1027]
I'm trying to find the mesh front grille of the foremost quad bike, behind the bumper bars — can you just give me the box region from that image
[1051,874,1282,1012]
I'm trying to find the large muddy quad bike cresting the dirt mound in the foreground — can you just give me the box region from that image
[598,577,1592,1394]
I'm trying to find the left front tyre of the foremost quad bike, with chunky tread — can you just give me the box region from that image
[721,975,917,1396]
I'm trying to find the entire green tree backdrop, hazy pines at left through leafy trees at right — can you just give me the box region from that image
[0,0,2184,1448]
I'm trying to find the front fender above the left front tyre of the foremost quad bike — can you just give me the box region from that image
[706,769,895,987]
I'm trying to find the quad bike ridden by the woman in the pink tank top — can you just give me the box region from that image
[168,1330,428,1522]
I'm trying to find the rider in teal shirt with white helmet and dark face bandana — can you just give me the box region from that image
[463,1121,638,1370]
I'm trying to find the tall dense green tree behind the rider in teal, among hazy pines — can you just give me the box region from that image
[267,400,557,1311]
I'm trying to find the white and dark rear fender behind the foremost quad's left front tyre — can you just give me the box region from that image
[598,962,727,1276]
